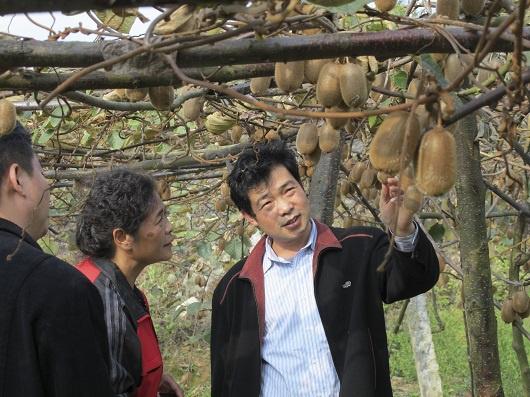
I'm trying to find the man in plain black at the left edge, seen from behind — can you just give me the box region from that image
[0,124,113,397]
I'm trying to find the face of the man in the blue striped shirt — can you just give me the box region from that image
[243,166,311,250]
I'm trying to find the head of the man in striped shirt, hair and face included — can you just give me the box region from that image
[228,140,310,251]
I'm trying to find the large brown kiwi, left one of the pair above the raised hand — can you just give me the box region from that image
[369,111,420,174]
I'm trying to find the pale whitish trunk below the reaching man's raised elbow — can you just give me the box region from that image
[407,294,443,397]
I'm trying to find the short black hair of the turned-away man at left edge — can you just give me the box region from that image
[0,122,35,184]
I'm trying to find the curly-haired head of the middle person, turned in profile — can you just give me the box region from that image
[76,169,173,266]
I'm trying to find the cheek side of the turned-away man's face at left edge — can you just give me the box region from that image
[22,156,50,240]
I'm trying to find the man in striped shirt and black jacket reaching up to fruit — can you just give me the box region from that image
[211,142,439,397]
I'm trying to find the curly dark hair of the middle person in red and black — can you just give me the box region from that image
[76,168,156,259]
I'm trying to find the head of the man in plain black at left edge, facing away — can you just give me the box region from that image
[0,123,50,240]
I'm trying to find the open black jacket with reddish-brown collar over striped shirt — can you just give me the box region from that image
[211,223,439,397]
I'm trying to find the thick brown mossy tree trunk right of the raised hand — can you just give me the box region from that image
[455,114,504,397]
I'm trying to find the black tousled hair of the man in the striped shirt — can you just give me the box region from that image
[228,140,302,216]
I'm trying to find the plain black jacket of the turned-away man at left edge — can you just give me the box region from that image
[0,218,112,397]
